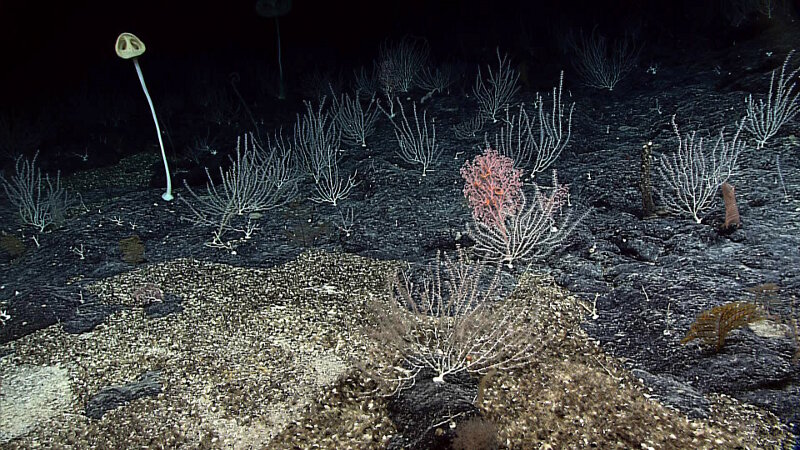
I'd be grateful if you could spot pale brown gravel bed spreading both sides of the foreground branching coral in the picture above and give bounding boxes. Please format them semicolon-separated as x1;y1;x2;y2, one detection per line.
0;252;791;449
